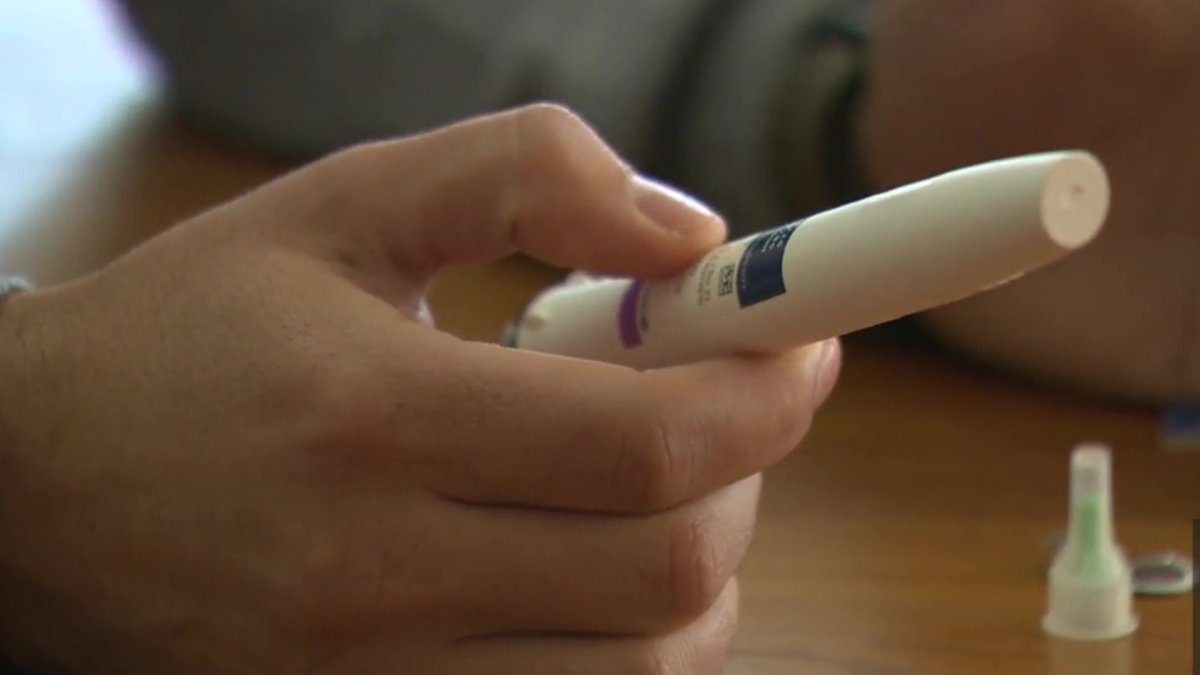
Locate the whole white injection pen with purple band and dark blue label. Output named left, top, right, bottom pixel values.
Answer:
left=505, top=151, right=1109, bottom=369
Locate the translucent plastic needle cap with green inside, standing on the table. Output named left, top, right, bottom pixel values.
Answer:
left=1042, top=443, right=1138, bottom=640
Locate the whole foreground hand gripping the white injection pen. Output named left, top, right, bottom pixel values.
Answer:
left=0, top=106, right=840, bottom=675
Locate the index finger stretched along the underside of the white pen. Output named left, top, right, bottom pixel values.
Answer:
left=394, top=340, right=840, bottom=513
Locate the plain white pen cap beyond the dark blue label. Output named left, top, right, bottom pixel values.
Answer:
left=775, top=151, right=1109, bottom=345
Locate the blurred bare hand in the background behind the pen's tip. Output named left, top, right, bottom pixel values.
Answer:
left=859, top=0, right=1200, bottom=401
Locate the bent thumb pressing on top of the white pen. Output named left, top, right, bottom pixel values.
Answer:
left=268, top=104, right=726, bottom=281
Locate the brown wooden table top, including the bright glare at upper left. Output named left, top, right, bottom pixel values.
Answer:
left=0, top=0, right=1200, bottom=675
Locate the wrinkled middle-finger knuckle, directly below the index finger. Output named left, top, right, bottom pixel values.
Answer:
left=665, top=511, right=727, bottom=617
